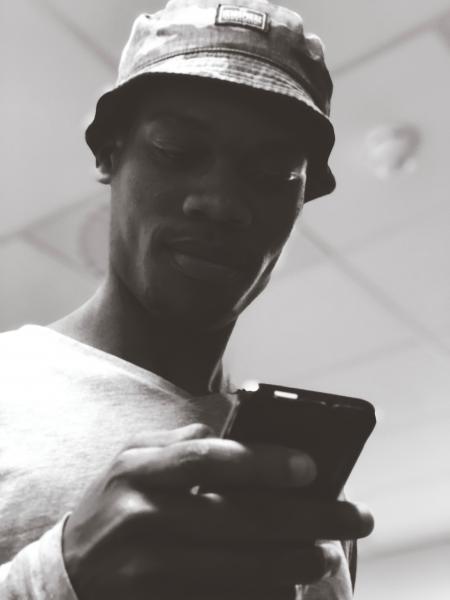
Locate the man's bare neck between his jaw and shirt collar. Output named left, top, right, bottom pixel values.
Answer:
left=49, top=277, right=233, bottom=395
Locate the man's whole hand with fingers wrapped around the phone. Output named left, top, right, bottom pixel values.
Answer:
left=63, top=425, right=373, bottom=600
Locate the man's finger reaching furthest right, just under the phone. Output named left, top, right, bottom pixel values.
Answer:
left=121, top=490, right=373, bottom=545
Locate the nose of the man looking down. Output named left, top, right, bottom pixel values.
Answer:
left=183, top=165, right=252, bottom=228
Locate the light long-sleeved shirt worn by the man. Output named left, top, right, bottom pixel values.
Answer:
left=0, top=325, right=351, bottom=600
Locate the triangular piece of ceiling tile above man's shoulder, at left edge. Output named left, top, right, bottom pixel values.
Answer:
left=0, top=237, right=96, bottom=331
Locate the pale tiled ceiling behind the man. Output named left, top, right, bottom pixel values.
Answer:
left=0, top=0, right=450, bottom=568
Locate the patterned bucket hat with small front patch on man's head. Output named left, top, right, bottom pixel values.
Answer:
left=85, top=0, right=336, bottom=201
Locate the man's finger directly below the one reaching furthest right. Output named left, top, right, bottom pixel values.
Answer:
left=105, top=538, right=341, bottom=591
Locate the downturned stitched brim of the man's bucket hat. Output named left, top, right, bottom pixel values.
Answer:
left=85, top=50, right=336, bottom=202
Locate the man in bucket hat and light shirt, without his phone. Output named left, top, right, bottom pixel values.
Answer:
left=0, top=0, right=373, bottom=600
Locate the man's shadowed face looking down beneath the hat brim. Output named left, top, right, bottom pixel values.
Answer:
left=106, top=78, right=307, bottom=330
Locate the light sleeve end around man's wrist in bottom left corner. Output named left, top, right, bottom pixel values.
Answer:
left=0, top=514, right=78, bottom=600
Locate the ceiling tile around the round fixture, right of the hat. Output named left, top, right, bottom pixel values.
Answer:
left=303, top=34, right=450, bottom=249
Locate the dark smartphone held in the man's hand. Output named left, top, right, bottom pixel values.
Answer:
left=223, top=383, right=376, bottom=500
